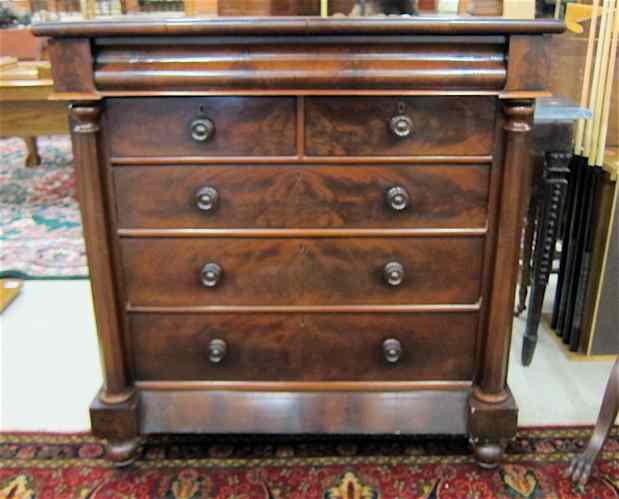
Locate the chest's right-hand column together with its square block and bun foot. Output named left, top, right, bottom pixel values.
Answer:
left=468, top=100, right=533, bottom=468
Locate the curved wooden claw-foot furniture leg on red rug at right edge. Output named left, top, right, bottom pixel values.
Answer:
left=567, top=358, right=619, bottom=485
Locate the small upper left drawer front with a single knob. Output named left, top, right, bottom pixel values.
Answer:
left=106, top=97, right=296, bottom=157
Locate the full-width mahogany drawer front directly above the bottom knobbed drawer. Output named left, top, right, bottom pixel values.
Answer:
left=122, top=237, right=484, bottom=306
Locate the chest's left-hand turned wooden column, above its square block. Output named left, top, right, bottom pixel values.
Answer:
left=70, top=104, right=133, bottom=404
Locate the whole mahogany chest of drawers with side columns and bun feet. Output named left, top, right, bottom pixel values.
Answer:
left=35, top=18, right=563, bottom=466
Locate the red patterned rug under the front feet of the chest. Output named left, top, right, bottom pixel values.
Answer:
left=0, top=428, right=619, bottom=499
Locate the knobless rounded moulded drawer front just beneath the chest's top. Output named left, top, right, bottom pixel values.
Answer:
left=94, top=37, right=506, bottom=91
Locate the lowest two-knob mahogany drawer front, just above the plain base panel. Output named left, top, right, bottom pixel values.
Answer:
left=131, top=312, right=478, bottom=381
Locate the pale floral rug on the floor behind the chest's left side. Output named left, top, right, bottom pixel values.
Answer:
left=0, top=136, right=88, bottom=279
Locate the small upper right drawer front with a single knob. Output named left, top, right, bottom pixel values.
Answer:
left=305, top=96, right=496, bottom=156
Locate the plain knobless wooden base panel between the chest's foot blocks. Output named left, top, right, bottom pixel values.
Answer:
left=141, top=389, right=470, bottom=435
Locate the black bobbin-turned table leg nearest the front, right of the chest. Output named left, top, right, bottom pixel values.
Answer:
left=522, top=152, right=571, bottom=366
